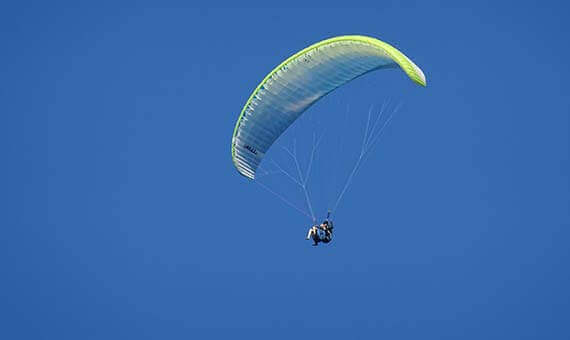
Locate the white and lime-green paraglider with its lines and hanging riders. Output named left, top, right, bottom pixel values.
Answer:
left=231, top=35, right=426, bottom=244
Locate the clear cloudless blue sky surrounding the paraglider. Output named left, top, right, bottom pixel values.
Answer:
left=0, top=1, right=570, bottom=339
